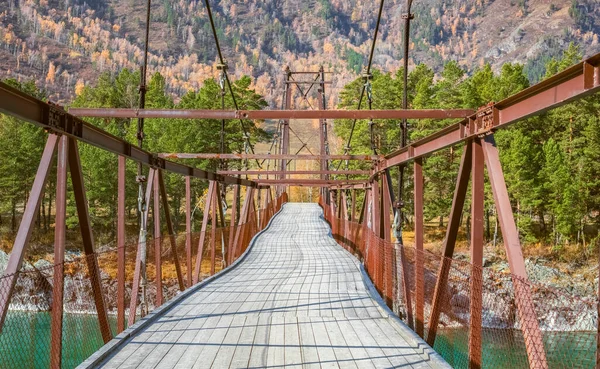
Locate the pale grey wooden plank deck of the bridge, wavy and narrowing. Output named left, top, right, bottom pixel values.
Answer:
left=88, top=203, right=448, bottom=369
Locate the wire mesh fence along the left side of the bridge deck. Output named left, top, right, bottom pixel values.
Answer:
left=0, top=194, right=285, bottom=369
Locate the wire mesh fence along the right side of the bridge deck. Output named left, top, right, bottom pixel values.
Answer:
left=321, top=198, right=598, bottom=368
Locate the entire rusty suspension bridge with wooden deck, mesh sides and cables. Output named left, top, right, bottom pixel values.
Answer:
left=0, top=0, right=600, bottom=369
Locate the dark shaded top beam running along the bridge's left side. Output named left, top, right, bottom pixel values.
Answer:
left=0, top=82, right=255, bottom=186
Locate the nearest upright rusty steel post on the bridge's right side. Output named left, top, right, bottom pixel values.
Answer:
left=469, top=139, right=485, bottom=369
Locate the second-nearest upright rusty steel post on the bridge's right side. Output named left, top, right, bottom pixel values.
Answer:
left=413, top=158, right=425, bottom=338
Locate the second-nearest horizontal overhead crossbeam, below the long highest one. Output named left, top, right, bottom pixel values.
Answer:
left=158, top=153, right=383, bottom=161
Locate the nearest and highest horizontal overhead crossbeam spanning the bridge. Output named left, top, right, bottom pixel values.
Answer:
left=69, top=108, right=474, bottom=120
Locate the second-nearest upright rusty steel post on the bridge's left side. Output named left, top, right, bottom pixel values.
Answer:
left=117, top=155, right=127, bottom=334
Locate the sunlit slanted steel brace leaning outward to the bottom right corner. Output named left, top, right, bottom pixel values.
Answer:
left=482, top=135, right=548, bottom=369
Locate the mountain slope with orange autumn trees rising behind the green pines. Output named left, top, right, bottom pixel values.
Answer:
left=0, top=0, right=600, bottom=108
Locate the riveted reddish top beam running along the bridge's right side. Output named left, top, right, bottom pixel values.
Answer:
left=377, top=54, right=600, bottom=171
